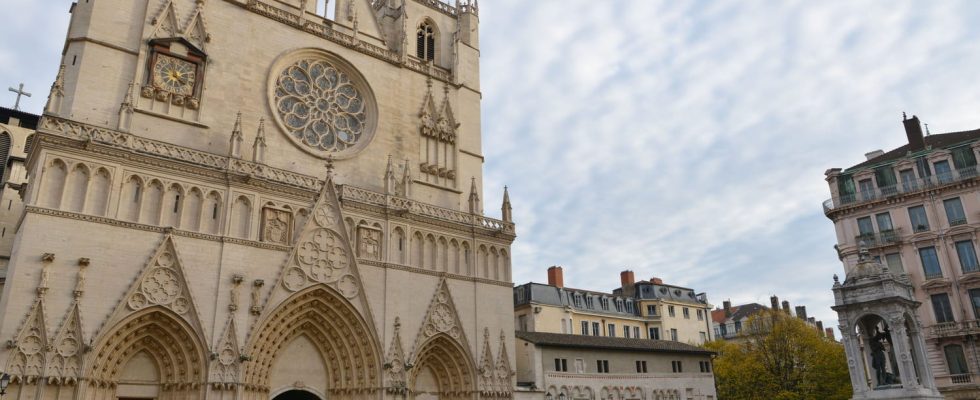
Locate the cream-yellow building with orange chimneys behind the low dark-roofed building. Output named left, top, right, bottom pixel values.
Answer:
left=514, top=266, right=712, bottom=345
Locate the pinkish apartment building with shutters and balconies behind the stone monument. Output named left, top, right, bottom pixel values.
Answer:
left=824, top=116, right=980, bottom=399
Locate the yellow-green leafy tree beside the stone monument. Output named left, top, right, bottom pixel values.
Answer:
left=706, top=311, right=852, bottom=400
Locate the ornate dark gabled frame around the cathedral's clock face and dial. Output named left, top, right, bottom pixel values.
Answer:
left=140, top=38, right=207, bottom=110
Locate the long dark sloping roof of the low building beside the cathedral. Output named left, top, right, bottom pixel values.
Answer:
left=515, top=331, right=715, bottom=355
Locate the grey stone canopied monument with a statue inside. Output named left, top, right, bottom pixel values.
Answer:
left=833, top=247, right=943, bottom=400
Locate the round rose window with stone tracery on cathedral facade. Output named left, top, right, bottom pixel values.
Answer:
left=272, top=58, right=370, bottom=153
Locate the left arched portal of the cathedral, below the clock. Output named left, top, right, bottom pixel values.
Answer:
left=85, top=306, right=207, bottom=399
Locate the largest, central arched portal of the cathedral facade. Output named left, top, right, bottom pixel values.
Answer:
left=244, top=285, right=382, bottom=399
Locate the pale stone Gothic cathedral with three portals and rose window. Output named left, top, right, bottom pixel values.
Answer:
left=0, top=0, right=515, bottom=400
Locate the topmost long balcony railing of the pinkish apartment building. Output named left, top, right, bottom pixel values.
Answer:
left=823, top=166, right=980, bottom=214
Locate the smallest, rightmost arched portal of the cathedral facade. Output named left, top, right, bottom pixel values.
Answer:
left=409, top=333, right=476, bottom=399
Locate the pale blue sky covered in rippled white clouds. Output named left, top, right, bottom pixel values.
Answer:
left=0, top=0, right=980, bottom=332
